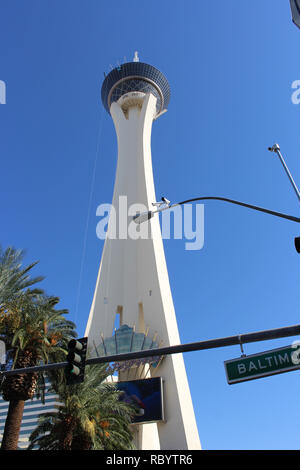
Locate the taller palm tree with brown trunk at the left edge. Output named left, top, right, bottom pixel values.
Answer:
left=0, top=289, right=76, bottom=450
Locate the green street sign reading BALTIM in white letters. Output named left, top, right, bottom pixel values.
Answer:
left=224, top=342, right=300, bottom=384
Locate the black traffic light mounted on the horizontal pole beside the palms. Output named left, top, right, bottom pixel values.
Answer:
left=65, top=338, right=87, bottom=385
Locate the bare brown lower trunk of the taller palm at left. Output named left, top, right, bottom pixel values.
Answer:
left=1, top=400, right=25, bottom=450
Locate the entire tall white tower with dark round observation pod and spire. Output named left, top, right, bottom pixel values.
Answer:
left=85, top=53, right=201, bottom=450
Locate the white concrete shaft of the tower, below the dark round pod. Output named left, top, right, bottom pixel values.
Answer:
left=85, top=62, right=200, bottom=450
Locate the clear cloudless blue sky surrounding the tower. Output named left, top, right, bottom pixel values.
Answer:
left=0, top=0, right=300, bottom=449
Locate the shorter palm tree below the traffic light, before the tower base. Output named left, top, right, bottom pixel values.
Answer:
left=28, top=364, right=135, bottom=450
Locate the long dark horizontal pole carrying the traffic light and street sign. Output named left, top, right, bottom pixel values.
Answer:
left=0, top=325, right=300, bottom=377
